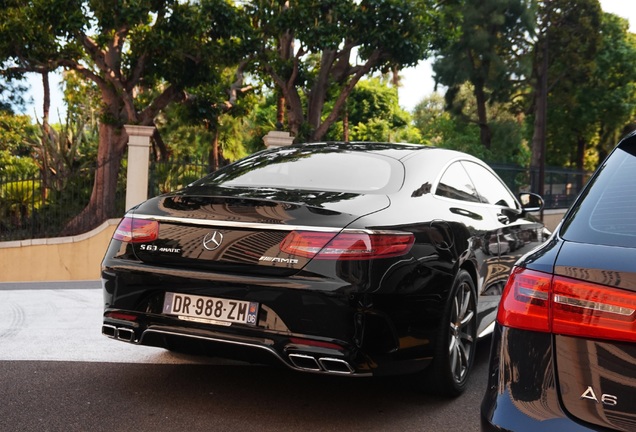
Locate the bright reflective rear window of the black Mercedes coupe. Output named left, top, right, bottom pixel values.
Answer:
left=195, top=148, right=404, bottom=193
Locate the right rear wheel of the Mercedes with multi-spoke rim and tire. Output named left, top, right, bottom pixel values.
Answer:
left=423, top=270, right=477, bottom=397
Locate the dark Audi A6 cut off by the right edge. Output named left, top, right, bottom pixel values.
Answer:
left=482, top=135, right=636, bottom=432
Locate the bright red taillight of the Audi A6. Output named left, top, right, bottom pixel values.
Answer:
left=497, top=268, right=636, bottom=342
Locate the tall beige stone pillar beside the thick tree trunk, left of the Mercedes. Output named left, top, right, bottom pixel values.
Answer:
left=124, top=125, right=155, bottom=210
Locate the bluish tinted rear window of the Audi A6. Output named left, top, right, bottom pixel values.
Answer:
left=561, top=145, right=636, bottom=248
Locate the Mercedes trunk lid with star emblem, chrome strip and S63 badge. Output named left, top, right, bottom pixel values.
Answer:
left=126, top=188, right=389, bottom=274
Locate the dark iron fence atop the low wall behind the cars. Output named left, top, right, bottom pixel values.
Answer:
left=0, top=162, right=590, bottom=241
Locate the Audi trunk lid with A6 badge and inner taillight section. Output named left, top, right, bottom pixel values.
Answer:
left=554, top=242, right=636, bottom=431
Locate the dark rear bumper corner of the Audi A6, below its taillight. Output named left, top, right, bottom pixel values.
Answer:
left=481, top=325, right=593, bottom=432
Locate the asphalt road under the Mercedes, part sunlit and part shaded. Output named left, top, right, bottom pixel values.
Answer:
left=0, top=281, right=490, bottom=432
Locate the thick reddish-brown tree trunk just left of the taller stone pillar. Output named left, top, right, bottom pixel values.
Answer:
left=62, top=123, right=128, bottom=236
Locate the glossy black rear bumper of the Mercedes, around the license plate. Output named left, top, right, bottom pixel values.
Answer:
left=102, top=267, right=442, bottom=376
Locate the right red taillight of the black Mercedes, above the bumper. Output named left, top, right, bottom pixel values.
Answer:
left=280, top=231, right=415, bottom=260
